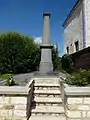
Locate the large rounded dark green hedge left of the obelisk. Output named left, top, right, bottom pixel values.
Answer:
left=0, top=32, right=40, bottom=74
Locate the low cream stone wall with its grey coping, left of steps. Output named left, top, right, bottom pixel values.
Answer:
left=0, top=81, right=34, bottom=120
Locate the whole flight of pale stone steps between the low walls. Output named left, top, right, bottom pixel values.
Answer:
left=30, top=78, right=66, bottom=120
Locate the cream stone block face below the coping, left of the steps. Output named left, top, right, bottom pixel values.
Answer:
left=0, top=95, right=27, bottom=120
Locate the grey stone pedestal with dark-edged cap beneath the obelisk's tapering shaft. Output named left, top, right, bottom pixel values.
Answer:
left=39, top=44, right=53, bottom=73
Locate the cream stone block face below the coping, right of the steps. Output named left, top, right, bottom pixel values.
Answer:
left=66, top=96, right=90, bottom=120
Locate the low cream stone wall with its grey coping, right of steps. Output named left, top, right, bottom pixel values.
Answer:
left=60, top=78, right=90, bottom=120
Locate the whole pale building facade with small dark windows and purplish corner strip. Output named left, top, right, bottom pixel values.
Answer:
left=63, top=0, right=90, bottom=54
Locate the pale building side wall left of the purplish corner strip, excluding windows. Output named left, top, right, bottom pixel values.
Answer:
left=64, top=0, right=83, bottom=54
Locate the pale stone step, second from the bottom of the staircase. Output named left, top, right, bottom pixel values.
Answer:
left=31, top=105, right=65, bottom=115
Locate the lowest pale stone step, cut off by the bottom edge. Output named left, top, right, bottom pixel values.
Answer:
left=29, top=115, right=66, bottom=120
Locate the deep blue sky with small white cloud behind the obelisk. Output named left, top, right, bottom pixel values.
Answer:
left=0, top=0, right=77, bottom=56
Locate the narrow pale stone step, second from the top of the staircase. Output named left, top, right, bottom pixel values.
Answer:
left=34, top=90, right=61, bottom=95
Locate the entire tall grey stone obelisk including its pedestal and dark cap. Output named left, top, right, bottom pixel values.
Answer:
left=39, top=13, right=53, bottom=75
